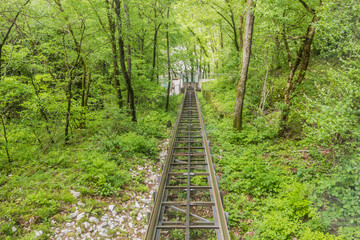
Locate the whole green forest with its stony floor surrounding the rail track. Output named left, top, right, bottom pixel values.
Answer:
left=0, top=0, right=360, bottom=240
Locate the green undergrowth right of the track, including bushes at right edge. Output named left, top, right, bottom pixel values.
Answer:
left=199, top=66, right=360, bottom=240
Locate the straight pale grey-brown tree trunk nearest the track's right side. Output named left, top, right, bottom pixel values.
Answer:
left=233, top=0, right=255, bottom=131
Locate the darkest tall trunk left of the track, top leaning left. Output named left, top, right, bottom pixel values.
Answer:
left=115, top=0, right=136, bottom=122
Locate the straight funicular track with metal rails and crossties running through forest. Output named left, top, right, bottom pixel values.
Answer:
left=145, top=86, right=230, bottom=240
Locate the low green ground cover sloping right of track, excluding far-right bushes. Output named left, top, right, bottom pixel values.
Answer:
left=199, top=80, right=360, bottom=240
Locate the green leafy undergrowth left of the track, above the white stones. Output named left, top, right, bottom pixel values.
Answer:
left=0, top=91, right=180, bottom=239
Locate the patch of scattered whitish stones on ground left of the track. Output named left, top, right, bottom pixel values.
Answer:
left=45, top=141, right=168, bottom=240
